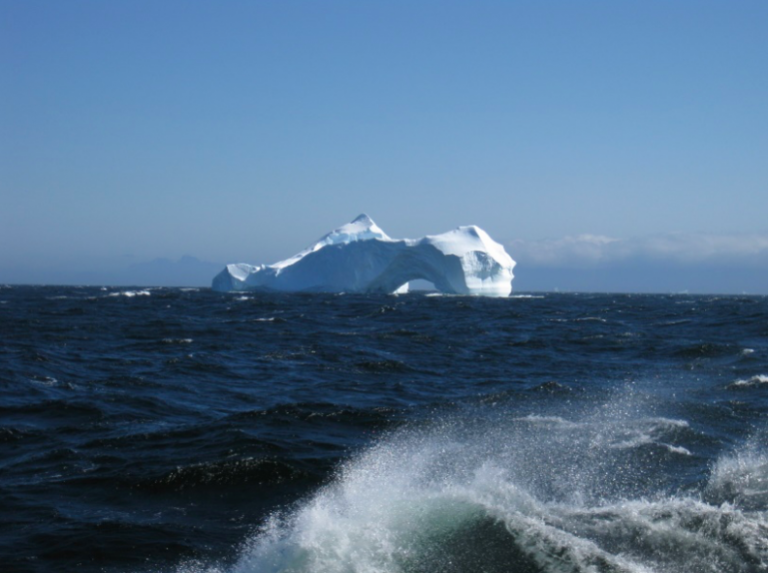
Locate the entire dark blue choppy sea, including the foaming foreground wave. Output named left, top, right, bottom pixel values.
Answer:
left=0, top=286, right=768, bottom=573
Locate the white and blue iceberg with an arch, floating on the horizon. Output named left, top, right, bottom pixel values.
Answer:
left=212, top=214, right=515, bottom=297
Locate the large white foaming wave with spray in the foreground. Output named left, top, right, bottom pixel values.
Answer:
left=179, top=398, right=768, bottom=573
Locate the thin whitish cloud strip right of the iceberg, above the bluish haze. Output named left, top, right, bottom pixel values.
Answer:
left=506, top=234, right=768, bottom=268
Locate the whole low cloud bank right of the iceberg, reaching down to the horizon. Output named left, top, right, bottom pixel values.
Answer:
left=505, top=234, right=768, bottom=294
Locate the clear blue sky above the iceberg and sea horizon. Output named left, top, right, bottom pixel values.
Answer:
left=0, top=0, right=768, bottom=292
